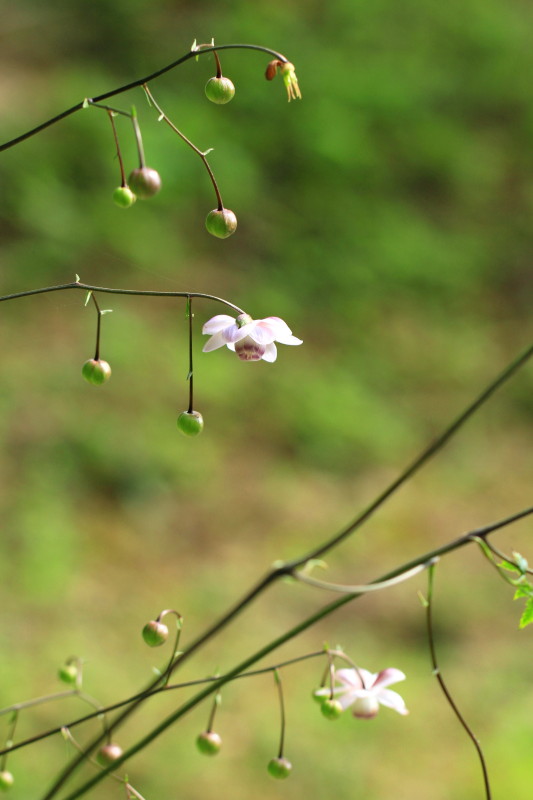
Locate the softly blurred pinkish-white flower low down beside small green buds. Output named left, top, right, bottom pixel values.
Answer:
left=315, top=667, right=409, bottom=719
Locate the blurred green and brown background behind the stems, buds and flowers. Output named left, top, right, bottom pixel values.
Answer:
left=0, top=0, right=533, bottom=800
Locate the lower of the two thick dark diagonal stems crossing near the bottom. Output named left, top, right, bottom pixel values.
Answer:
left=43, top=507, right=533, bottom=800
